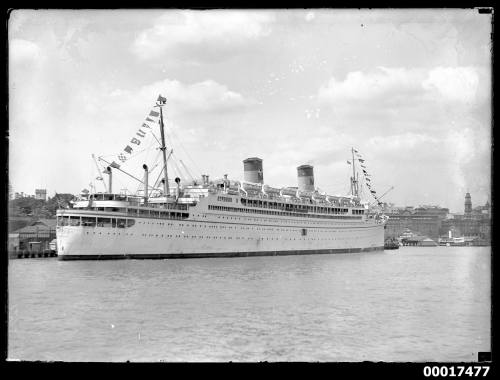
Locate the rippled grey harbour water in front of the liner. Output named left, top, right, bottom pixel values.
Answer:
left=8, top=247, right=491, bottom=362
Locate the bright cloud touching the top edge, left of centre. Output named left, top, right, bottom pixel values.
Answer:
left=132, top=11, right=274, bottom=59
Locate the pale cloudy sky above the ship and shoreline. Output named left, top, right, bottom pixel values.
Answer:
left=8, top=9, right=492, bottom=212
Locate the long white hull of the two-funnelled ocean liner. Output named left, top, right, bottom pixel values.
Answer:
left=57, top=211, right=384, bottom=259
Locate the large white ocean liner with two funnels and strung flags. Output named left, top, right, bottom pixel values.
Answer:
left=56, top=95, right=387, bottom=260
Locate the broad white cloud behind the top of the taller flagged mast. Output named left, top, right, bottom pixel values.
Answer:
left=73, top=78, right=254, bottom=151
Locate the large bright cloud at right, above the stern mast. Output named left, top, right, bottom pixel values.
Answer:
left=315, top=67, right=490, bottom=137
